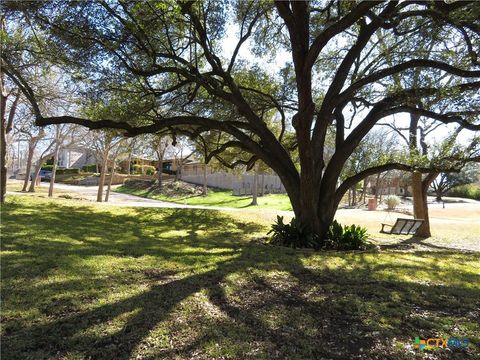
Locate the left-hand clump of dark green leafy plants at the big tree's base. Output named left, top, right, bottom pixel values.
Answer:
left=267, top=215, right=318, bottom=248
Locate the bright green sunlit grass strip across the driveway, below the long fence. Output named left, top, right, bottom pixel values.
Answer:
left=114, top=183, right=292, bottom=210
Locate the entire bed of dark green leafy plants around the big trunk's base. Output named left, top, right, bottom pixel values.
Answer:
left=267, top=216, right=368, bottom=250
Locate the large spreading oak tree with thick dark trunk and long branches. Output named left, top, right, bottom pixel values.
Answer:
left=2, top=0, right=480, bottom=237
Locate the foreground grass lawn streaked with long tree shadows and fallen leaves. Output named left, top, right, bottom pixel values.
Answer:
left=1, top=196, right=480, bottom=360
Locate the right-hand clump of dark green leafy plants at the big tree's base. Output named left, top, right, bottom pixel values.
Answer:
left=325, top=220, right=368, bottom=250
